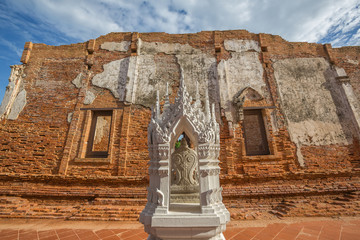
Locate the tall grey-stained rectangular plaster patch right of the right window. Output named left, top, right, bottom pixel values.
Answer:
left=274, top=58, right=349, bottom=165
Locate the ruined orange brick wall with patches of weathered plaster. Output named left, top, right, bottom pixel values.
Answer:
left=0, top=30, right=360, bottom=220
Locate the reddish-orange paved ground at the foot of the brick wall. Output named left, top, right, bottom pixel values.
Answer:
left=0, top=218, right=360, bottom=240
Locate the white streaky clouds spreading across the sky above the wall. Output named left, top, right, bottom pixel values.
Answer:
left=2, top=0, right=360, bottom=44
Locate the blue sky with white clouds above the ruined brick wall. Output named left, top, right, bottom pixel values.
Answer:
left=0, top=0, right=360, bottom=100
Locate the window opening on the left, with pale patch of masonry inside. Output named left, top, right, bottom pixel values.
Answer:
left=86, top=111, right=112, bottom=158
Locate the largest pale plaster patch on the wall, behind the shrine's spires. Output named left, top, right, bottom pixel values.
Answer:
left=92, top=40, right=217, bottom=107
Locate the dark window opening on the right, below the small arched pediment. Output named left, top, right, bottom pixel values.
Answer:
left=244, top=109, right=270, bottom=156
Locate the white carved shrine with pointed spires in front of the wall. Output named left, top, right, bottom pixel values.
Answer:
left=140, top=73, right=230, bottom=240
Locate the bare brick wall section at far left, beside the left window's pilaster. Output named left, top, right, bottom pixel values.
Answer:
left=0, top=44, right=85, bottom=174
